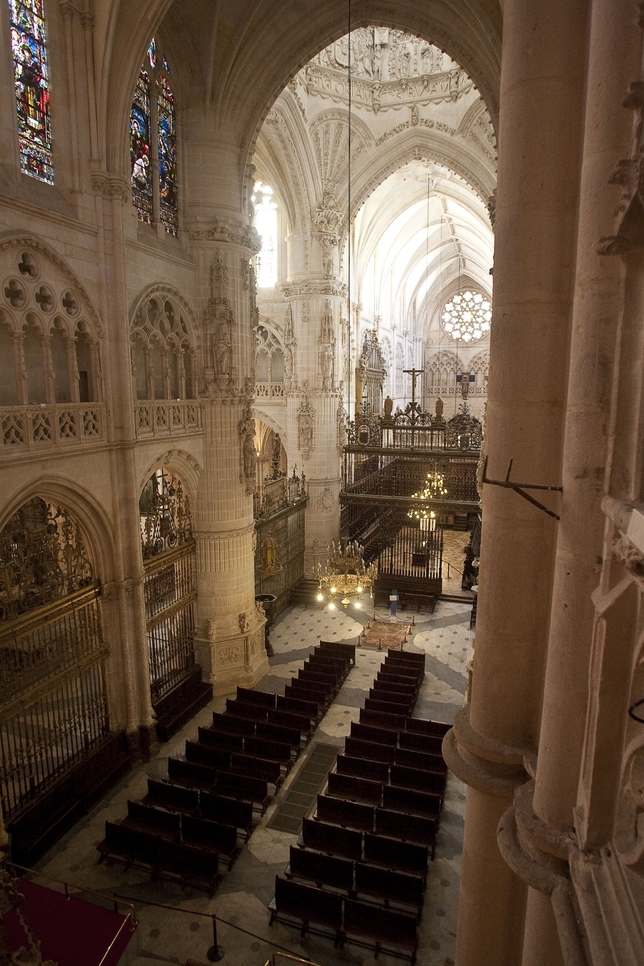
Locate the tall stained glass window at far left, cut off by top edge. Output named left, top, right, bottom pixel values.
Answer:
left=9, top=0, right=54, bottom=184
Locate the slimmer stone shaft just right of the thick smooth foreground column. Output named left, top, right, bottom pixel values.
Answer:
left=509, top=7, right=640, bottom=966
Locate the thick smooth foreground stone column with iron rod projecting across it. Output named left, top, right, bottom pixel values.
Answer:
left=445, top=0, right=586, bottom=966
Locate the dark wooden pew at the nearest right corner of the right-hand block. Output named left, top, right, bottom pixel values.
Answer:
left=340, top=899, right=418, bottom=966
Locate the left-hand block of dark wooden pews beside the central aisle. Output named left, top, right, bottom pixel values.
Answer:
left=97, top=644, right=355, bottom=895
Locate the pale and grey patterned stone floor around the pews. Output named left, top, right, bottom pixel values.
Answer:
left=32, top=601, right=473, bottom=966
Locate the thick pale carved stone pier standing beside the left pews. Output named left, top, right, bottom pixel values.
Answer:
left=190, top=233, right=268, bottom=694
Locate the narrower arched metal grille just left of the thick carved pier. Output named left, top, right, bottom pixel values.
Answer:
left=139, top=469, right=197, bottom=705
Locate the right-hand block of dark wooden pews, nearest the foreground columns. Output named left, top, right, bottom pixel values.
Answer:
left=270, top=652, right=449, bottom=964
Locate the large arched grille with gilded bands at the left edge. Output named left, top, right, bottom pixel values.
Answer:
left=0, top=497, right=109, bottom=820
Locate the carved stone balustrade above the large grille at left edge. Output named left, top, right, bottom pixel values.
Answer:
left=0, top=403, right=106, bottom=459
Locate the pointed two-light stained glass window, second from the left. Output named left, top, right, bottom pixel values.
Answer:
left=130, top=37, right=178, bottom=235
